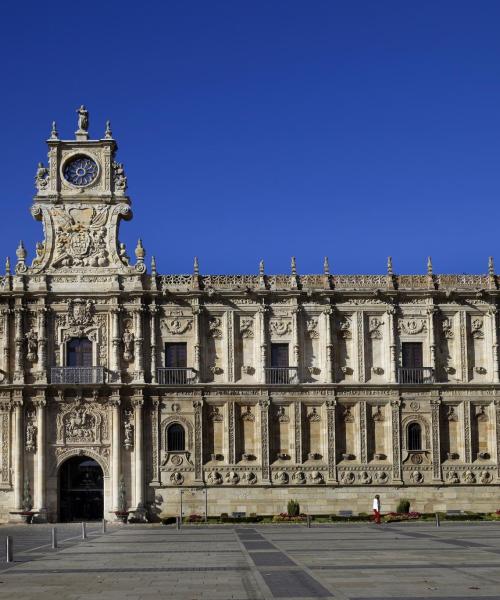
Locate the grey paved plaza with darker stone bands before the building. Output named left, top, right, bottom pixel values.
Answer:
left=0, top=523, right=500, bottom=600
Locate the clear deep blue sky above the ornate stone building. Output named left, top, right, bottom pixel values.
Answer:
left=0, top=0, right=500, bottom=273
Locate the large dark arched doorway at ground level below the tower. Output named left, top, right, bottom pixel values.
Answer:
left=59, top=456, right=104, bottom=521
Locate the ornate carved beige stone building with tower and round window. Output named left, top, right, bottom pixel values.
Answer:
left=0, top=107, right=500, bottom=520
